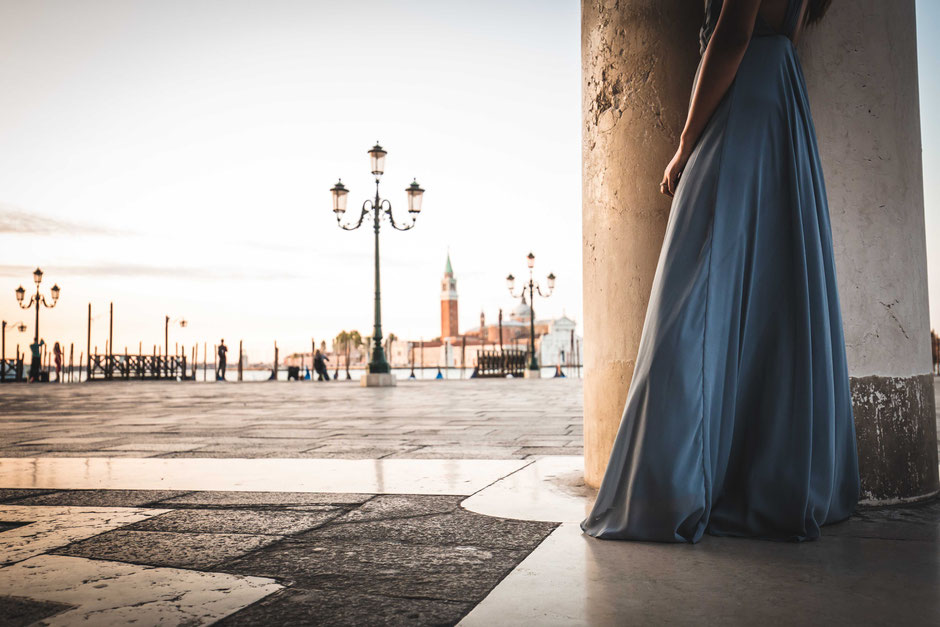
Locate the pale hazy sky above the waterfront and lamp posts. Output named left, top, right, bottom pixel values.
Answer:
left=0, top=0, right=940, bottom=360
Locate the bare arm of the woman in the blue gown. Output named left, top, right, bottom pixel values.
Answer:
left=660, top=0, right=761, bottom=196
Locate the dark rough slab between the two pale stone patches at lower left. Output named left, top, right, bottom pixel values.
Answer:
left=55, top=529, right=281, bottom=570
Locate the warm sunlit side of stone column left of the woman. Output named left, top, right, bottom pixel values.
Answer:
left=581, top=0, right=703, bottom=486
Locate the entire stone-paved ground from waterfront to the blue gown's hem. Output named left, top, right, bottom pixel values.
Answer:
left=0, top=380, right=940, bottom=625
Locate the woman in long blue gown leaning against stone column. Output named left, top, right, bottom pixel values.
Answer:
left=581, top=0, right=859, bottom=542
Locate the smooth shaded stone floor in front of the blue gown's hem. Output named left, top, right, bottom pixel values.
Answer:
left=460, top=523, right=940, bottom=626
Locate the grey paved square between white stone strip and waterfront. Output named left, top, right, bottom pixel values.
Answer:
left=0, top=379, right=582, bottom=459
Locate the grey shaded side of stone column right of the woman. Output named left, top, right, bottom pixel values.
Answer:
left=800, top=0, right=940, bottom=503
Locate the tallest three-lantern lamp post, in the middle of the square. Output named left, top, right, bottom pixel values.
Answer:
left=330, top=142, right=424, bottom=387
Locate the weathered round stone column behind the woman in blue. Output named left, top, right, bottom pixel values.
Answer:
left=582, top=0, right=938, bottom=503
